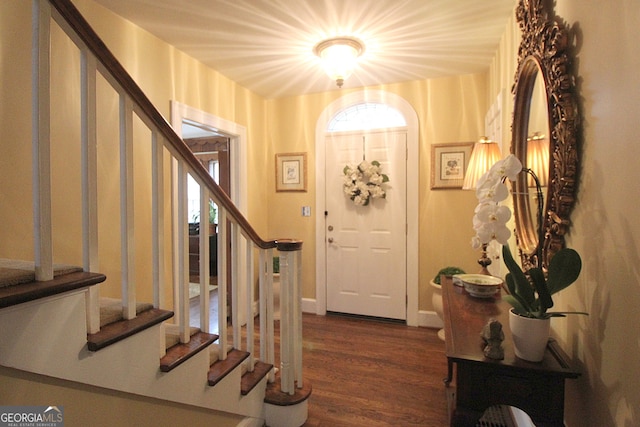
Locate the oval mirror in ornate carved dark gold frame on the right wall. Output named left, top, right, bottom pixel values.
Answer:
left=511, top=0, right=579, bottom=269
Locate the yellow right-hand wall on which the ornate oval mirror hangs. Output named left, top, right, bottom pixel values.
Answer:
left=489, top=0, right=640, bottom=426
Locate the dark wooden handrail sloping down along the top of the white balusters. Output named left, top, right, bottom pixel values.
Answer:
left=49, top=0, right=277, bottom=249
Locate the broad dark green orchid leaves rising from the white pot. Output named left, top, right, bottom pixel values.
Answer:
left=502, top=245, right=587, bottom=319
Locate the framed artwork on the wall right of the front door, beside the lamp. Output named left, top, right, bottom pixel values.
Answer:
left=431, top=142, right=473, bottom=190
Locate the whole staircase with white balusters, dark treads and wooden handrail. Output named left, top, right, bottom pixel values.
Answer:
left=0, top=0, right=311, bottom=427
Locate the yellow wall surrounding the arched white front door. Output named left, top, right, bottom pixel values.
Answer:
left=268, top=74, right=488, bottom=310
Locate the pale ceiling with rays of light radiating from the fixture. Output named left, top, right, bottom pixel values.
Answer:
left=96, top=0, right=516, bottom=98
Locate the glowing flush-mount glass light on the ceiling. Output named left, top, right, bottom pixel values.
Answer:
left=313, top=37, right=364, bottom=87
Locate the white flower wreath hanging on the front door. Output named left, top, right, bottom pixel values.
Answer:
left=342, top=160, right=389, bottom=206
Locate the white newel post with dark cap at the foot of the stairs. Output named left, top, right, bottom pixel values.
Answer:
left=276, top=240, right=302, bottom=395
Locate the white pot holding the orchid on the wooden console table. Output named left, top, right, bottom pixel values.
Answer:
left=509, top=309, right=551, bottom=362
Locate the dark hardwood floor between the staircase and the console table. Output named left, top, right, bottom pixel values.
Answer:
left=303, top=314, right=448, bottom=427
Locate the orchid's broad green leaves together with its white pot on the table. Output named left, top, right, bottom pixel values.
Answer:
left=502, top=245, right=587, bottom=362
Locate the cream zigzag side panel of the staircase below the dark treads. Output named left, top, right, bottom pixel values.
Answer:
left=0, top=289, right=267, bottom=419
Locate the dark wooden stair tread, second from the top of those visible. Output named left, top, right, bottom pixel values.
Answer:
left=87, top=308, right=173, bottom=351
